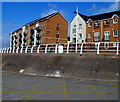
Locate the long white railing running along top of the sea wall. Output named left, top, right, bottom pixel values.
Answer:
left=0, top=42, right=120, bottom=55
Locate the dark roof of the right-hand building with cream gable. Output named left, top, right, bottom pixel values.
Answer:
left=74, top=10, right=120, bottom=22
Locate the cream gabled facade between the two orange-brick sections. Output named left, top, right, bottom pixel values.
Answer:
left=70, top=12, right=86, bottom=43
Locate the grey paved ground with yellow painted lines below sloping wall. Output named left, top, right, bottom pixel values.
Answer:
left=2, top=72, right=119, bottom=102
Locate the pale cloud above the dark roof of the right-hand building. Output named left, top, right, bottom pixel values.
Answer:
left=87, top=2, right=118, bottom=14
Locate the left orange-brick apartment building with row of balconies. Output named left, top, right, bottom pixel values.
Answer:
left=10, top=12, right=68, bottom=47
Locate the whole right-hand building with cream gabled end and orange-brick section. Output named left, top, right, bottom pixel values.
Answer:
left=70, top=11, right=120, bottom=45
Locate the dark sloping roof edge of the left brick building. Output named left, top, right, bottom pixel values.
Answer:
left=12, top=12, right=59, bottom=34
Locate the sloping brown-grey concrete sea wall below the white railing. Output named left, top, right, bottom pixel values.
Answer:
left=2, top=54, right=120, bottom=80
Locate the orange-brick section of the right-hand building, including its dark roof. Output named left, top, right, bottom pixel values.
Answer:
left=86, top=11, right=120, bottom=42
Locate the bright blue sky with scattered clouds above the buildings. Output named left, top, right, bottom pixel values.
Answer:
left=0, top=2, right=118, bottom=48
